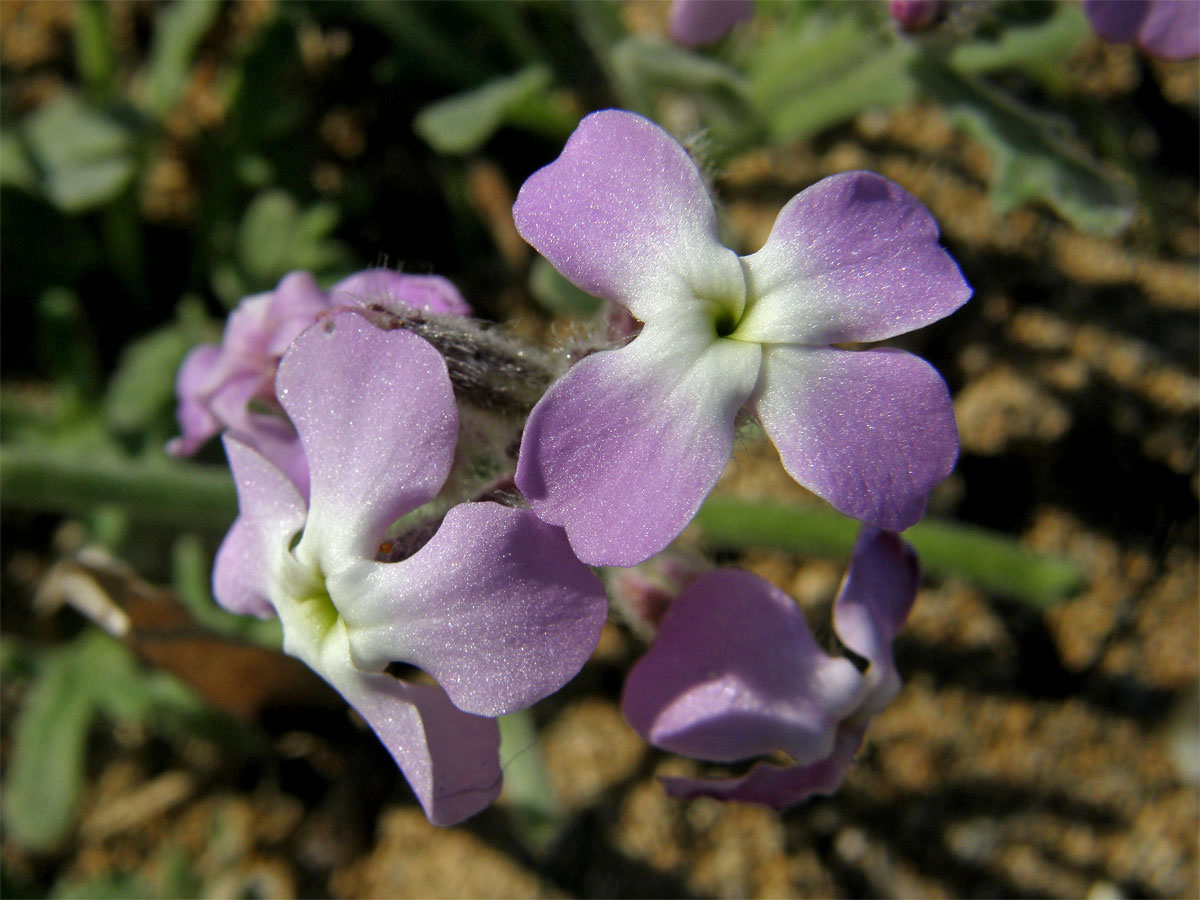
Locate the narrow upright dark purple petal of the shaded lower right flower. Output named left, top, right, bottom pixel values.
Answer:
left=833, top=526, right=920, bottom=719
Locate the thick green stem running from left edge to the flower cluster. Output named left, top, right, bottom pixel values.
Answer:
left=0, top=446, right=238, bottom=529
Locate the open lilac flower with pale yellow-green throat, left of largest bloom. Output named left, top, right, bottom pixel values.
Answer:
left=214, top=311, right=607, bottom=824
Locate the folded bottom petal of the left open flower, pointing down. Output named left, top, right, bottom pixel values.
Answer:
left=320, top=665, right=503, bottom=826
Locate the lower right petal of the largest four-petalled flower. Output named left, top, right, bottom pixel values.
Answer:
left=752, top=346, right=959, bottom=532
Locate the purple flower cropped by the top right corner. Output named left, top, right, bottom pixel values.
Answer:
left=1084, top=0, right=1200, bottom=60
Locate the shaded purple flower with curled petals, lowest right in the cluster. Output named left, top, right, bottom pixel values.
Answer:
left=622, top=527, right=918, bottom=810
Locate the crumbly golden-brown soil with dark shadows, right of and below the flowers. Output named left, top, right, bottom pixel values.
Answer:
left=4, top=8, right=1200, bottom=899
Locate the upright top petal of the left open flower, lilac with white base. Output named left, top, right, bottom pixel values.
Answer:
left=276, top=312, right=458, bottom=566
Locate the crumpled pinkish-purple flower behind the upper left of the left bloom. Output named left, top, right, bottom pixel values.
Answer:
left=167, top=269, right=470, bottom=493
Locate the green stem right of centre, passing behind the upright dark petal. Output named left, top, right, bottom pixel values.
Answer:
left=694, top=494, right=1082, bottom=607
